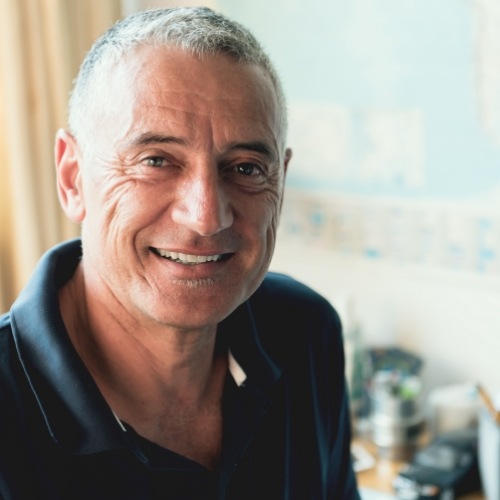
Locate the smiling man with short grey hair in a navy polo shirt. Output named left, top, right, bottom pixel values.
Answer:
left=0, top=8, right=358, bottom=500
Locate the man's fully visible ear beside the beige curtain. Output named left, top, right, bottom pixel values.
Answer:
left=55, top=129, right=85, bottom=223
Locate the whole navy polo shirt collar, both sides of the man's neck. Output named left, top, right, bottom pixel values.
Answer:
left=11, top=239, right=280, bottom=454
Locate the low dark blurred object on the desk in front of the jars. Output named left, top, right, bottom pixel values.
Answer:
left=393, top=430, right=480, bottom=500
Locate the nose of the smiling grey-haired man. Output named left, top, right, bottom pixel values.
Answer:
left=172, top=166, right=233, bottom=236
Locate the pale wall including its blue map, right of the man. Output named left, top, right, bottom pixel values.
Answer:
left=130, top=0, right=500, bottom=396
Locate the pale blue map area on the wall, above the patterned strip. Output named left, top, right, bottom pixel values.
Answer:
left=217, top=0, right=500, bottom=204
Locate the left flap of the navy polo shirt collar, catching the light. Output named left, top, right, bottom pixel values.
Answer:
left=11, top=240, right=128, bottom=454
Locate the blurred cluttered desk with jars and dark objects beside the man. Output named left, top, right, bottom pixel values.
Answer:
left=352, top=349, right=500, bottom=500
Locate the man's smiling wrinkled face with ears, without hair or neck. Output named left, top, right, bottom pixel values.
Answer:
left=56, top=46, right=290, bottom=338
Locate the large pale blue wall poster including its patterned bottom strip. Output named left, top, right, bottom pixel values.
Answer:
left=216, top=0, right=500, bottom=275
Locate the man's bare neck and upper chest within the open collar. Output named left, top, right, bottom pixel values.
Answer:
left=59, top=265, right=227, bottom=469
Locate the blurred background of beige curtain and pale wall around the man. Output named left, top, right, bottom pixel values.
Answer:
left=0, top=0, right=500, bottom=438
